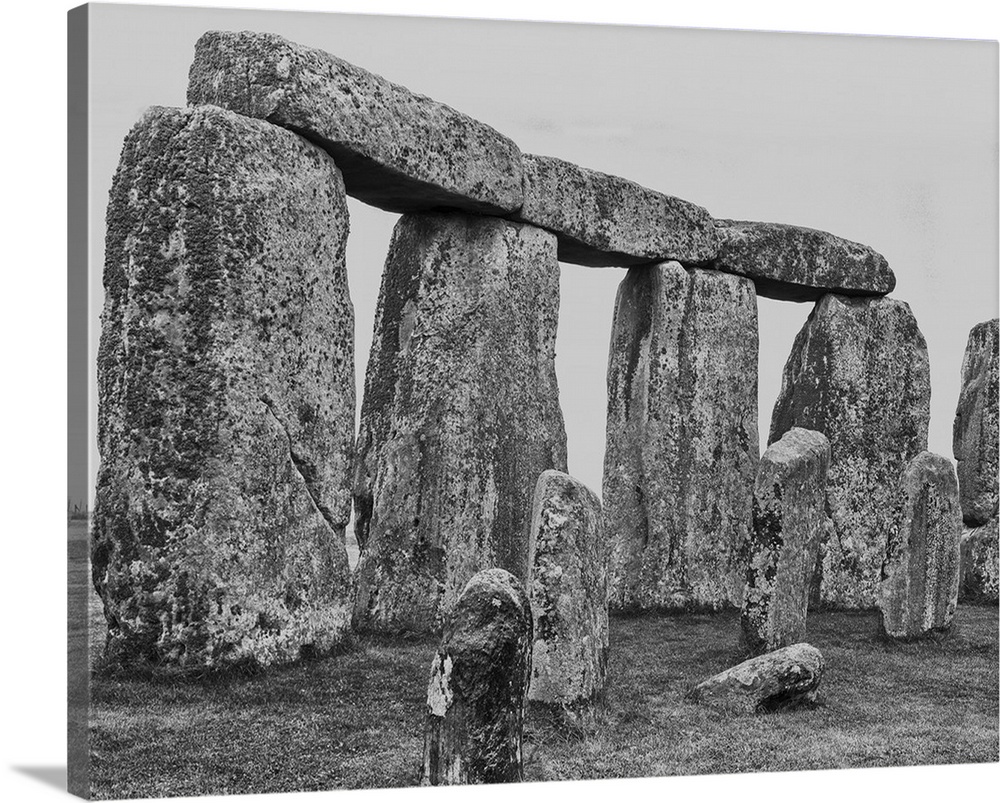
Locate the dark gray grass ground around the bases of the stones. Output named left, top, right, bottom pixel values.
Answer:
left=80, top=532, right=1000, bottom=799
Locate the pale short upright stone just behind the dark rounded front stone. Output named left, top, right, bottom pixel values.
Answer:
left=528, top=471, right=608, bottom=711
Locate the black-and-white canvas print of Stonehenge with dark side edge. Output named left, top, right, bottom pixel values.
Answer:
left=68, top=4, right=998, bottom=799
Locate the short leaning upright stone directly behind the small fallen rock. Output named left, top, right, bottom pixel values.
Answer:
left=740, top=427, right=830, bottom=653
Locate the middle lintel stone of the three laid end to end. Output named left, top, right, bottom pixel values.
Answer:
left=516, top=154, right=718, bottom=267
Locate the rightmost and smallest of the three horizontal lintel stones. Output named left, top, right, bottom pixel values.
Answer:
left=713, top=220, right=896, bottom=301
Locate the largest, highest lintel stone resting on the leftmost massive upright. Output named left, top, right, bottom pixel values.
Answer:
left=188, top=31, right=522, bottom=214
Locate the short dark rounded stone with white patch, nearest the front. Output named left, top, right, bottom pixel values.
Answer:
left=421, top=569, right=531, bottom=786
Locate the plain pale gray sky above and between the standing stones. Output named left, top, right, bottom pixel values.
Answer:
left=86, top=4, right=998, bottom=506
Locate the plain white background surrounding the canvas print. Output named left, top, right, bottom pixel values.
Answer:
left=0, top=0, right=1000, bottom=801
